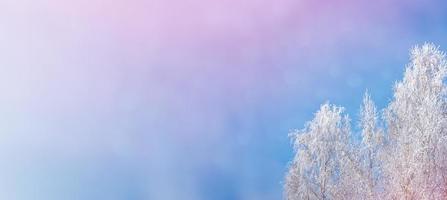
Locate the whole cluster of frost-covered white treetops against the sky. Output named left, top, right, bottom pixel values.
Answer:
left=284, top=44, right=447, bottom=200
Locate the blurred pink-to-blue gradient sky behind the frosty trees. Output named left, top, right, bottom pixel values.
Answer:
left=0, top=0, right=447, bottom=200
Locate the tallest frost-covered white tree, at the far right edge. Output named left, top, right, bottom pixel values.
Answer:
left=385, top=44, right=447, bottom=199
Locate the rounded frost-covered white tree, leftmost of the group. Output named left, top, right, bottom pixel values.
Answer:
left=285, top=103, right=350, bottom=200
